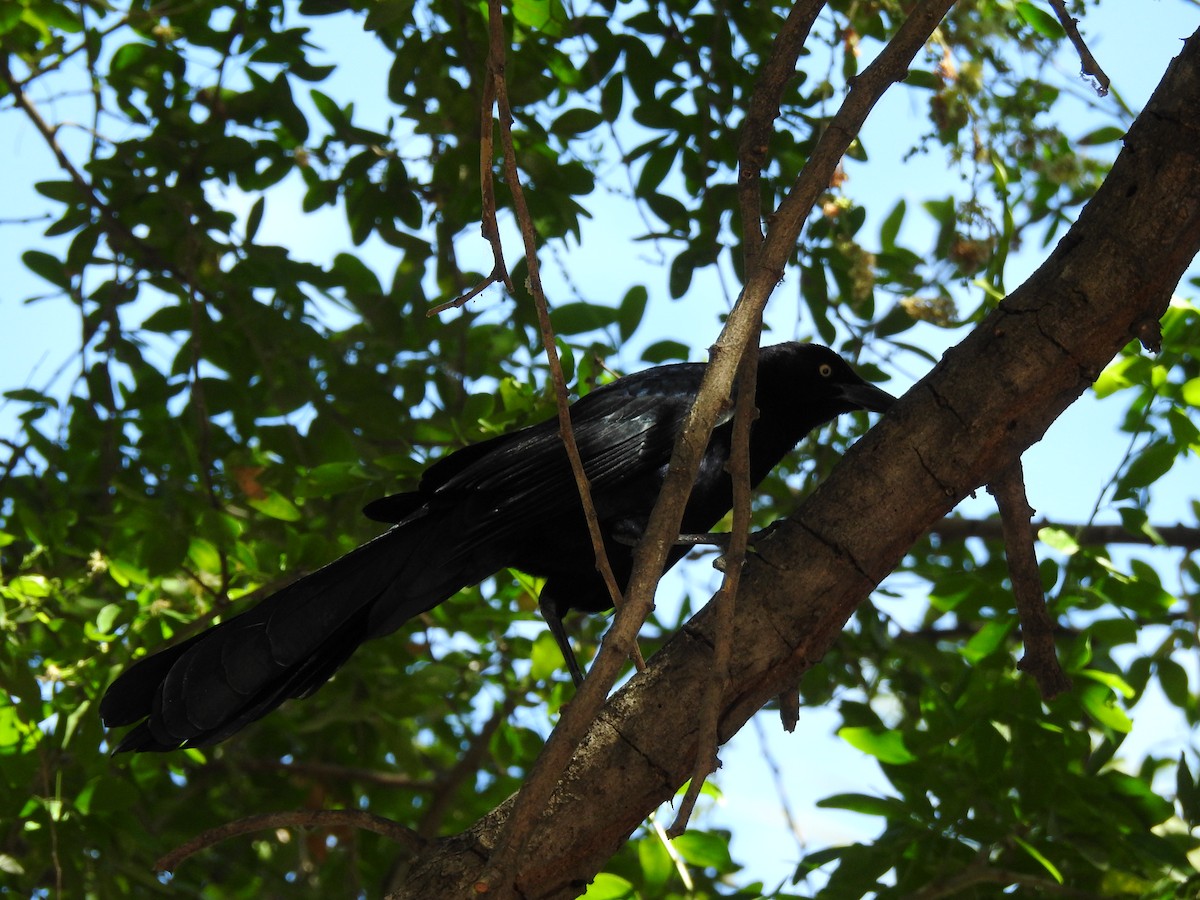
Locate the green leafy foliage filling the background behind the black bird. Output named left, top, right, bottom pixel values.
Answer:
left=0, top=0, right=1200, bottom=898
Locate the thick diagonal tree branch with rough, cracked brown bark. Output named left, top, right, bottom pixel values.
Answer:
left=392, top=28, right=1200, bottom=898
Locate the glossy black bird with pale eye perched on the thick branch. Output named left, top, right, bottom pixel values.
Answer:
left=100, top=343, right=893, bottom=752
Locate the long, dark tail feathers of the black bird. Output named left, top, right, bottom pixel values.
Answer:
left=100, top=513, right=482, bottom=752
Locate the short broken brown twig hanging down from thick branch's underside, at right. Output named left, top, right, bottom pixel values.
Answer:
left=988, top=460, right=1070, bottom=700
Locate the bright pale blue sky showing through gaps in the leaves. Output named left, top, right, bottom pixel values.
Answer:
left=0, top=0, right=1200, bottom=886
